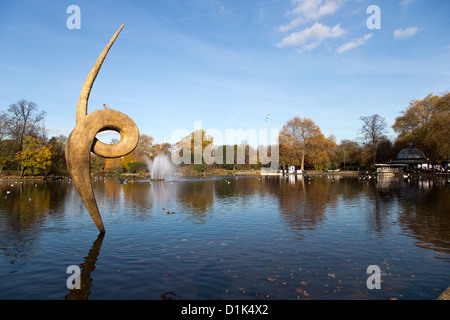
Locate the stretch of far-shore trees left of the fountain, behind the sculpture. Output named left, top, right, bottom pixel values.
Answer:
left=0, top=99, right=166, bottom=176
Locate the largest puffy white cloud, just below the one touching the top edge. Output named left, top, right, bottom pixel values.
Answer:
left=277, top=22, right=345, bottom=51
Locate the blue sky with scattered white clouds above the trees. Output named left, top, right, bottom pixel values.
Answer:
left=0, top=0, right=450, bottom=146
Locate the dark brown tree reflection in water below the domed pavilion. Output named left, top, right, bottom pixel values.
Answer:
left=368, top=177, right=450, bottom=253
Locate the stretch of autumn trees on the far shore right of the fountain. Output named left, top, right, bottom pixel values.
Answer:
left=174, top=92, right=450, bottom=171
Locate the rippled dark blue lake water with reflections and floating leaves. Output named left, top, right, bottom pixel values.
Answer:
left=0, top=176, right=450, bottom=300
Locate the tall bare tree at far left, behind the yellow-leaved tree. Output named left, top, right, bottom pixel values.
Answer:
left=7, top=99, right=45, bottom=151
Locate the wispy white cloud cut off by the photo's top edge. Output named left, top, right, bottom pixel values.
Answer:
left=278, top=0, right=346, bottom=32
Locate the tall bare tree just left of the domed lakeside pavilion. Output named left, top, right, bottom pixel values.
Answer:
left=359, top=114, right=387, bottom=165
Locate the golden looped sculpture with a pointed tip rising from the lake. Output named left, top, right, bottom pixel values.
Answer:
left=66, top=24, right=139, bottom=233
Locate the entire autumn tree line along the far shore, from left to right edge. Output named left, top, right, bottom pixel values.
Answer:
left=0, top=92, right=450, bottom=175
